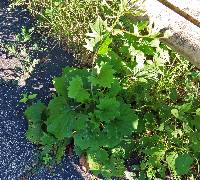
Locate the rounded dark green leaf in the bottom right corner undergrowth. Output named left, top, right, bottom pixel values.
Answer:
left=175, top=154, right=193, bottom=176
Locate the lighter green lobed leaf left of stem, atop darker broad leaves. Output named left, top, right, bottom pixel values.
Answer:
left=67, top=76, right=90, bottom=103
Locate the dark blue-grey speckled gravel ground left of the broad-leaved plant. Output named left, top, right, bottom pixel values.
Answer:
left=0, top=0, right=89, bottom=180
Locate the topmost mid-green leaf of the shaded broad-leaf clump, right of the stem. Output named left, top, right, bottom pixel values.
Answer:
left=89, top=63, right=114, bottom=88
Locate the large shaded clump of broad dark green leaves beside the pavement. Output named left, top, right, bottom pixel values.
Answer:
left=25, top=63, right=138, bottom=176
